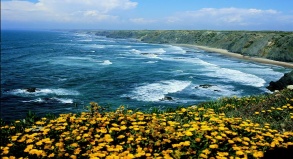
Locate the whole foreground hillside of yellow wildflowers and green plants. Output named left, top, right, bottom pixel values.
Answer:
left=0, top=90, right=293, bottom=159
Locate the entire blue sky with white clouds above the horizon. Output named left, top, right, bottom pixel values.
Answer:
left=1, top=0, right=293, bottom=31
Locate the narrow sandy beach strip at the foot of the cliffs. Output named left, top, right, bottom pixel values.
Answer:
left=175, top=44, right=293, bottom=68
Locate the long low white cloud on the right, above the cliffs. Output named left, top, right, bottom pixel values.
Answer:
left=167, top=8, right=292, bottom=26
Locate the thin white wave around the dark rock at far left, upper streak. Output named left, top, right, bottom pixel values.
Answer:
left=7, top=88, right=79, bottom=96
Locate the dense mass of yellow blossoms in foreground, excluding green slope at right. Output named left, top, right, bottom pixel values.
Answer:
left=0, top=103, right=293, bottom=159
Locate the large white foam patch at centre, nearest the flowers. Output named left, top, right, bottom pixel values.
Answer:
left=124, top=80, right=191, bottom=101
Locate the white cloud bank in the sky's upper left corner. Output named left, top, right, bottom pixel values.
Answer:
left=1, top=0, right=137, bottom=22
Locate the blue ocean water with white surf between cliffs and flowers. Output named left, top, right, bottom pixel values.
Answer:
left=1, top=31, right=289, bottom=120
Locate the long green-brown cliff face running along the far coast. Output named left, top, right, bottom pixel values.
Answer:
left=95, top=30, right=293, bottom=62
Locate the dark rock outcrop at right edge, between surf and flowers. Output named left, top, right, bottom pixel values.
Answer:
left=267, top=71, right=293, bottom=91
